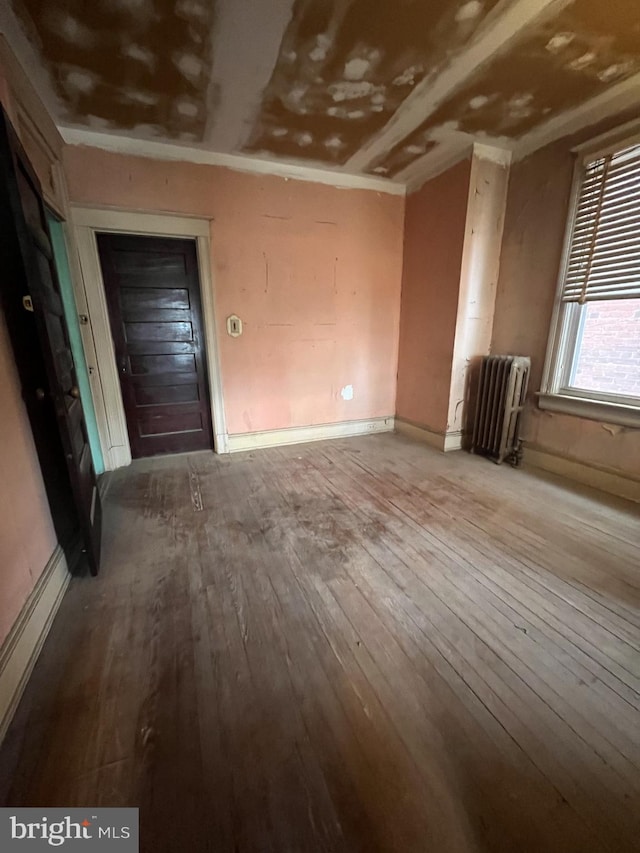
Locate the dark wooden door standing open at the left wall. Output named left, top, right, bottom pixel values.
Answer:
left=0, top=106, right=102, bottom=574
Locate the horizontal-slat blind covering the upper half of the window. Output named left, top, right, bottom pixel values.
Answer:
left=562, top=145, right=640, bottom=303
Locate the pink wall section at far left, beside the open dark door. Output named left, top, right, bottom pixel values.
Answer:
left=0, top=317, right=56, bottom=643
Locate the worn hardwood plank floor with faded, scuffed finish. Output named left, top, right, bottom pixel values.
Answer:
left=0, top=435, right=640, bottom=853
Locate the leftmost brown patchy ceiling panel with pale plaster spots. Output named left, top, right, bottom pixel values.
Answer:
left=12, top=0, right=215, bottom=142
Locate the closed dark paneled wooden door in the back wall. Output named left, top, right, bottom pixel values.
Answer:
left=98, top=234, right=213, bottom=458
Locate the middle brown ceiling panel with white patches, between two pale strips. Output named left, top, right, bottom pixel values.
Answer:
left=244, top=0, right=498, bottom=164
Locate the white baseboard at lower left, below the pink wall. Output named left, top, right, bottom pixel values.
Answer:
left=0, top=545, right=71, bottom=743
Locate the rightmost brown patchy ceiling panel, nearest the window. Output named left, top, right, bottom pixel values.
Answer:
left=380, top=0, right=640, bottom=175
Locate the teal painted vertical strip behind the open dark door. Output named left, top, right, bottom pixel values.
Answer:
left=47, top=213, right=104, bottom=474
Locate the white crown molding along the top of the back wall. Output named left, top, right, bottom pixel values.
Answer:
left=58, top=127, right=405, bottom=196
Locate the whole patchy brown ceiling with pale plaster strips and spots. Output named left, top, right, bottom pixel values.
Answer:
left=3, top=0, right=640, bottom=187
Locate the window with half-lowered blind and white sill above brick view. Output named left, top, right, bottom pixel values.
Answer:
left=539, top=135, right=640, bottom=425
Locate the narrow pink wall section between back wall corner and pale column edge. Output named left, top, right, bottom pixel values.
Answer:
left=396, top=160, right=471, bottom=433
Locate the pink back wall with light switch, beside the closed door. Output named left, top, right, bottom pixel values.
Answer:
left=64, top=146, right=404, bottom=434
